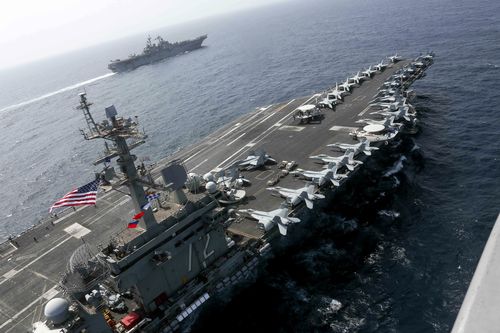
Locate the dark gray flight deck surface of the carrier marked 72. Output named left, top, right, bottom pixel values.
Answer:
left=0, top=61, right=408, bottom=333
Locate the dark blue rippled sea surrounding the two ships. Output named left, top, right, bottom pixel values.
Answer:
left=0, top=0, right=500, bottom=332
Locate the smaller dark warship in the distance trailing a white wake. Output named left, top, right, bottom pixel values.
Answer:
left=108, top=35, right=207, bottom=72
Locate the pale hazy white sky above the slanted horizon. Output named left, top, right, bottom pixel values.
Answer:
left=0, top=0, right=286, bottom=68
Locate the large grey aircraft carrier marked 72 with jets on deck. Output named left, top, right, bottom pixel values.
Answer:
left=0, top=54, right=433, bottom=332
